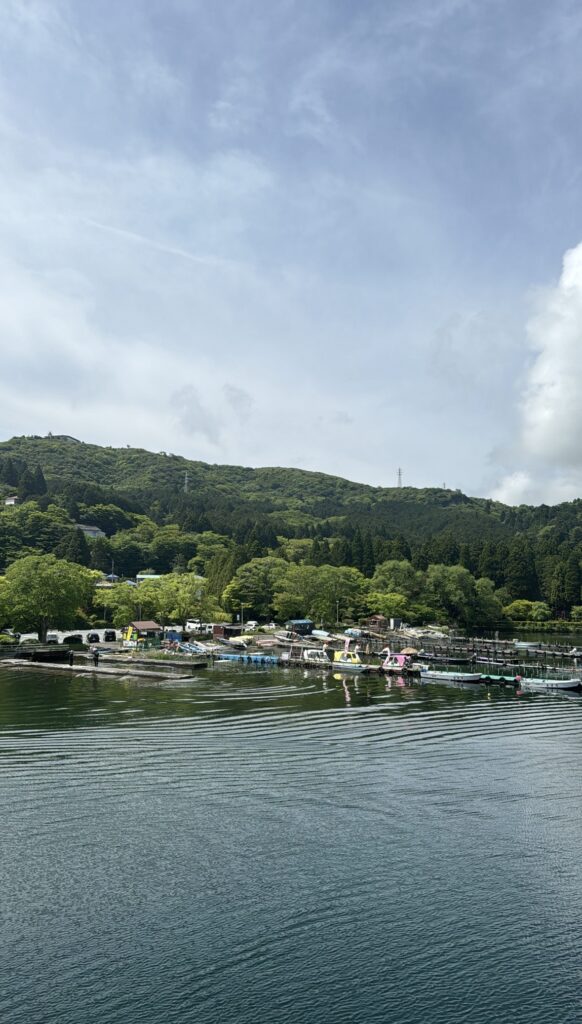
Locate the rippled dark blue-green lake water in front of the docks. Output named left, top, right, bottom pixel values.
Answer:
left=0, top=666, right=582, bottom=1024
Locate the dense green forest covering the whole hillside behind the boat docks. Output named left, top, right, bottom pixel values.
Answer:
left=0, top=435, right=582, bottom=626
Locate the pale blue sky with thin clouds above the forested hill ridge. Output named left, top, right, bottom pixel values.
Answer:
left=0, top=0, right=582, bottom=504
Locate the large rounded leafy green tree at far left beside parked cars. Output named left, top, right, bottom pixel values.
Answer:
left=4, top=555, right=97, bottom=642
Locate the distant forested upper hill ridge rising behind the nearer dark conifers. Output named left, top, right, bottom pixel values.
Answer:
left=0, top=436, right=545, bottom=541
